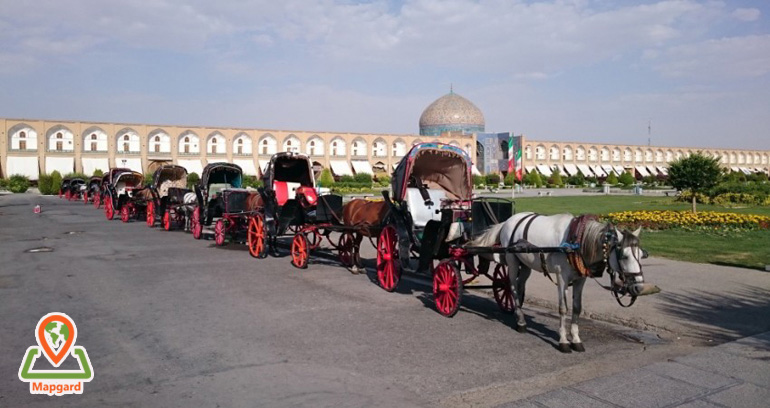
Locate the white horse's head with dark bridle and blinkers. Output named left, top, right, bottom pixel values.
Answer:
left=605, top=227, right=660, bottom=297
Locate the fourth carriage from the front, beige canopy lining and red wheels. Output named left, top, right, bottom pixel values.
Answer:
left=146, top=164, right=195, bottom=231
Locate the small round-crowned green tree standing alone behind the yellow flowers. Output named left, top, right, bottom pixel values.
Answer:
left=668, top=152, right=722, bottom=214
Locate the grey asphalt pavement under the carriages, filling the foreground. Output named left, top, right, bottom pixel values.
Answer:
left=0, top=194, right=770, bottom=407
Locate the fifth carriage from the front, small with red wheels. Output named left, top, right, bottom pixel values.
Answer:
left=104, top=169, right=146, bottom=222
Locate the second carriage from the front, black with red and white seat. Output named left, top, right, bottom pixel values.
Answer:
left=247, top=152, right=318, bottom=260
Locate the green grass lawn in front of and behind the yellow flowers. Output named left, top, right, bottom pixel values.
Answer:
left=516, top=196, right=770, bottom=270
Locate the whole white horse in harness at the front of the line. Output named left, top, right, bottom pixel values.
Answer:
left=469, top=213, right=660, bottom=353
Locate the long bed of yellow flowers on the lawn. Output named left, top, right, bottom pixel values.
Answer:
left=604, top=211, right=770, bottom=230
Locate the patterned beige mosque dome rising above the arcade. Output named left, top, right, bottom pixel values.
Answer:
left=420, top=90, right=484, bottom=136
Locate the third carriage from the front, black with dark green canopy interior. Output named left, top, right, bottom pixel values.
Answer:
left=190, top=162, right=248, bottom=241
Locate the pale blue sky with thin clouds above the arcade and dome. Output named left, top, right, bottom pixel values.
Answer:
left=0, top=0, right=770, bottom=150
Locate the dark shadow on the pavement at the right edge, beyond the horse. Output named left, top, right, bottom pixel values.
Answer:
left=658, top=284, right=770, bottom=341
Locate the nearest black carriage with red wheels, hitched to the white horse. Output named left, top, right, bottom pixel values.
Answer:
left=377, top=143, right=514, bottom=316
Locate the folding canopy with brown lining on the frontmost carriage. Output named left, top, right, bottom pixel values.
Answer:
left=391, top=143, right=473, bottom=201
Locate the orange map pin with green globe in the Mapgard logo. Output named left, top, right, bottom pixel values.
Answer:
left=35, top=313, right=78, bottom=367
